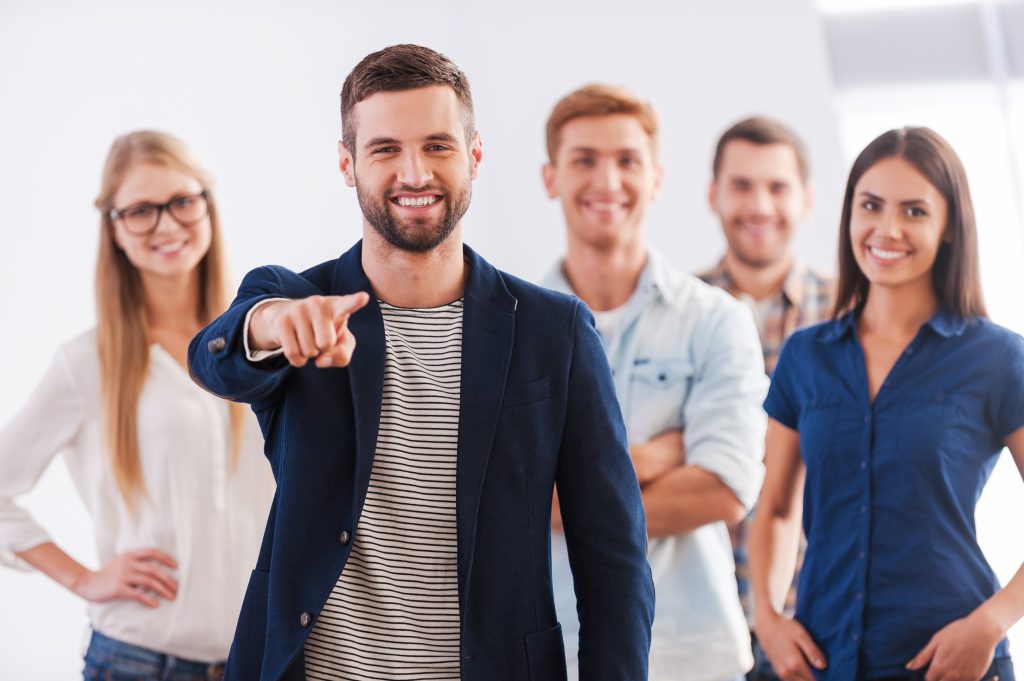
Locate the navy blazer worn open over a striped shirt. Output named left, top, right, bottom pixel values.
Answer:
left=188, top=243, right=654, bottom=681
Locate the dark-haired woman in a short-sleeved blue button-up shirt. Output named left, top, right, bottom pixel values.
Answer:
left=751, top=128, right=1024, bottom=681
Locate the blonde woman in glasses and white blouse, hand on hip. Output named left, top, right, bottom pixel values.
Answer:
left=0, top=131, right=273, bottom=681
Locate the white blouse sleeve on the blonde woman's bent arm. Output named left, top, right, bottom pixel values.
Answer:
left=0, top=352, right=85, bottom=569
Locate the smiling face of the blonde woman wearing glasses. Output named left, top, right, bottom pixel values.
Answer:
left=113, top=163, right=213, bottom=279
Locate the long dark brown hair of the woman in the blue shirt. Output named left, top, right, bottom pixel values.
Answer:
left=833, top=128, right=988, bottom=318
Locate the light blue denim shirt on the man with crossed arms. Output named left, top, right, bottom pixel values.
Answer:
left=544, top=252, right=768, bottom=681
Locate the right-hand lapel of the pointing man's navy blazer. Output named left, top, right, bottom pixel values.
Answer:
left=456, top=247, right=516, bottom=612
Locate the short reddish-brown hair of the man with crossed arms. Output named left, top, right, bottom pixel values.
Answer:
left=547, top=83, right=658, bottom=163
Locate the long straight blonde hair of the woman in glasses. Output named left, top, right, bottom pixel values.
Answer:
left=95, top=130, right=244, bottom=509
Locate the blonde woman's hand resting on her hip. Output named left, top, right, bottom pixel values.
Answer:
left=72, top=549, right=178, bottom=607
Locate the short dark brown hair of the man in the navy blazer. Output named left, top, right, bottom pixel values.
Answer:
left=341, top=45, right=476, bottom=156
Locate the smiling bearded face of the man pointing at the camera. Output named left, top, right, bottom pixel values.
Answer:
left=339, top=85, right=482, bottom=253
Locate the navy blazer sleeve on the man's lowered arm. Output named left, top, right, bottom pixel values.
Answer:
left=556, top=302, right=654, bottom=681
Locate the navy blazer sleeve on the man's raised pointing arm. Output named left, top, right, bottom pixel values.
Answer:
left=188, top=261, right=323, bottom=411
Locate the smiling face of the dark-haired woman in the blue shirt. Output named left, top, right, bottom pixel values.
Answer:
left=850, top=157, right=947, bottom=290
